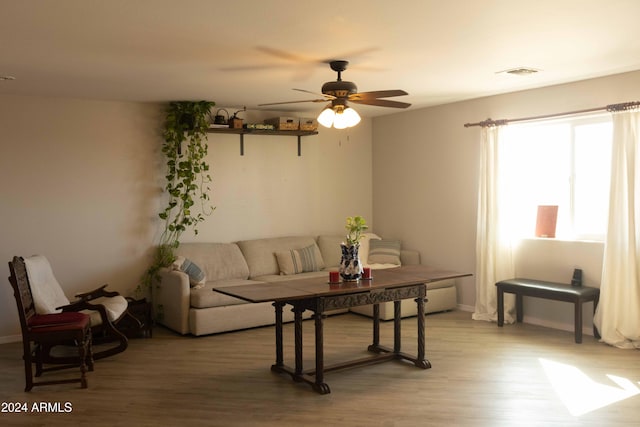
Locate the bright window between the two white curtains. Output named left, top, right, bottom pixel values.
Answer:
left=500, top=115, right=612, bottom=240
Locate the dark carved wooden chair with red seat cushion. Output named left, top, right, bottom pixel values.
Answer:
left=9, top=257, right=93, bottom=391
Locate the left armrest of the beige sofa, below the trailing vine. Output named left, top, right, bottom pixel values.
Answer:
left=151, top=268, right=191, bottom=335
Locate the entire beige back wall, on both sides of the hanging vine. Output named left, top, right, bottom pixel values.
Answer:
left=0, top=96, right=373, bottom=342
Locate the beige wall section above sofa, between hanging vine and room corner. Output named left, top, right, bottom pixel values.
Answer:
left=178, top=107, right=373, bottom=242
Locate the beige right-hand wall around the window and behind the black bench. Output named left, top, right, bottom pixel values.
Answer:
left=373, top=72, right=640, bottom=336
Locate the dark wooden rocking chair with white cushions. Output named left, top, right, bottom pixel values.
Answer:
left=24, top=255, right=139, bottom=363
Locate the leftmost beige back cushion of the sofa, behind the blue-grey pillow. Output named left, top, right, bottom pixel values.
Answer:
left=176, top=243, right=249, bottom=281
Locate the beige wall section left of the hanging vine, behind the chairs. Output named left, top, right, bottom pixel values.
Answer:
left=0, top=96, right=160, bottom=340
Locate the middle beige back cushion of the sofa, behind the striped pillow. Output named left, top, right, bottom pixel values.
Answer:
left=237, top=236, right=324, bottom=278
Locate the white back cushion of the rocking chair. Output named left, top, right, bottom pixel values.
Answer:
left=24, top=255, right=69, bottom=314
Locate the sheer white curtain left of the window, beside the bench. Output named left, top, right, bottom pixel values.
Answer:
left=473, top=126, right=515, bottom=323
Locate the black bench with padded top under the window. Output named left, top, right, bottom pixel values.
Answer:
left=496, top=279, right=600, bottom=344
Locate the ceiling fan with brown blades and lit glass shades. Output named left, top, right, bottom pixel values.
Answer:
left=258, top=60, right=411, bottom=129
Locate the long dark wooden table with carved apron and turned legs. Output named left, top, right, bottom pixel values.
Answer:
left=214, top=265, right=470, bottom=394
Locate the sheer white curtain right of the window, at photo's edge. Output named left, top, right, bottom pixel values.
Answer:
left=594, top=109, right=640, bottom=348
